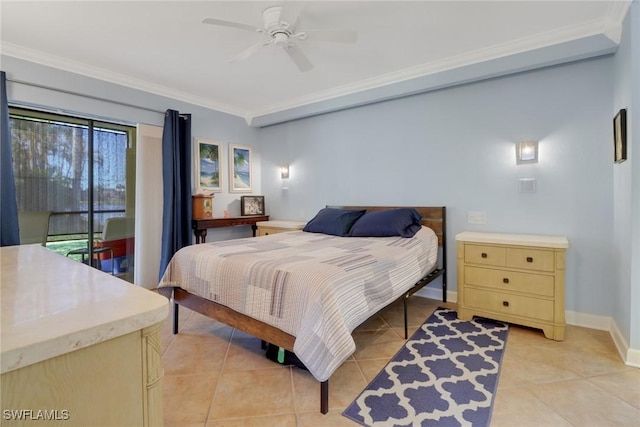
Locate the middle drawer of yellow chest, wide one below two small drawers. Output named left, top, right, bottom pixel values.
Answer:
left=464, top=266, right=554, bottom=297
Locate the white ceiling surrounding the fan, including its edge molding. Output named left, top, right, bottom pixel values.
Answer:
left=0, top=0, right=629, bottom=126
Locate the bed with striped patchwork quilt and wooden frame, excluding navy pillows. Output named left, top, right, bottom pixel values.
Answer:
left=159, top=206, right=446, bottom=413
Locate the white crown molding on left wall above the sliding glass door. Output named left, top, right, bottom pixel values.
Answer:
left=0, top=42, right=245, bottom=118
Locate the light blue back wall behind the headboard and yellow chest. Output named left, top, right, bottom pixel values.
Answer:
left=260, top=57, right=615, bottom=316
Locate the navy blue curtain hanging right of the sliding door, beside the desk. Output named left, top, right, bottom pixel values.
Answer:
left=159, top=110, right=192, bottom=278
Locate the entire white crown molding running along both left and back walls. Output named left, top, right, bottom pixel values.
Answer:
left=1, top=5, right=631, bottom=127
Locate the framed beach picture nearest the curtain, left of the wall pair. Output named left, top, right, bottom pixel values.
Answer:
left=193, top=138, right=222, bottom=191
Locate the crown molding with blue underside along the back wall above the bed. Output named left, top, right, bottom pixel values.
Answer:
left=247, top=18, right=621, bottom=127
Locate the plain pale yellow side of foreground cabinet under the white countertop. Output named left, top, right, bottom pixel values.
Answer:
left=2, top=331, right=146, bottom=427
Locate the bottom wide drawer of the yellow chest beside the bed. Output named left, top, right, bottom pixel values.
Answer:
left=464, top=288, right=554, bottom=322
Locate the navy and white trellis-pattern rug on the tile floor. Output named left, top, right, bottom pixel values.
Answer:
left=342, top=308, right=509, bottom=427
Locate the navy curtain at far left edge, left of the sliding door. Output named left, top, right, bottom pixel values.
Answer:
left=0, top=71, right=20, bottom=246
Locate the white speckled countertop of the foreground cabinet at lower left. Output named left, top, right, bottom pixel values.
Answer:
left=0, top=245, right=169, bottom=373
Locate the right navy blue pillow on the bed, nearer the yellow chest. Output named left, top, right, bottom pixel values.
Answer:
left=349, top=208, right=422, bottom=237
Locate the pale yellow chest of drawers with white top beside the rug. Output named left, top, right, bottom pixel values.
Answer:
left=456, top=232, right=569, bottom=341
